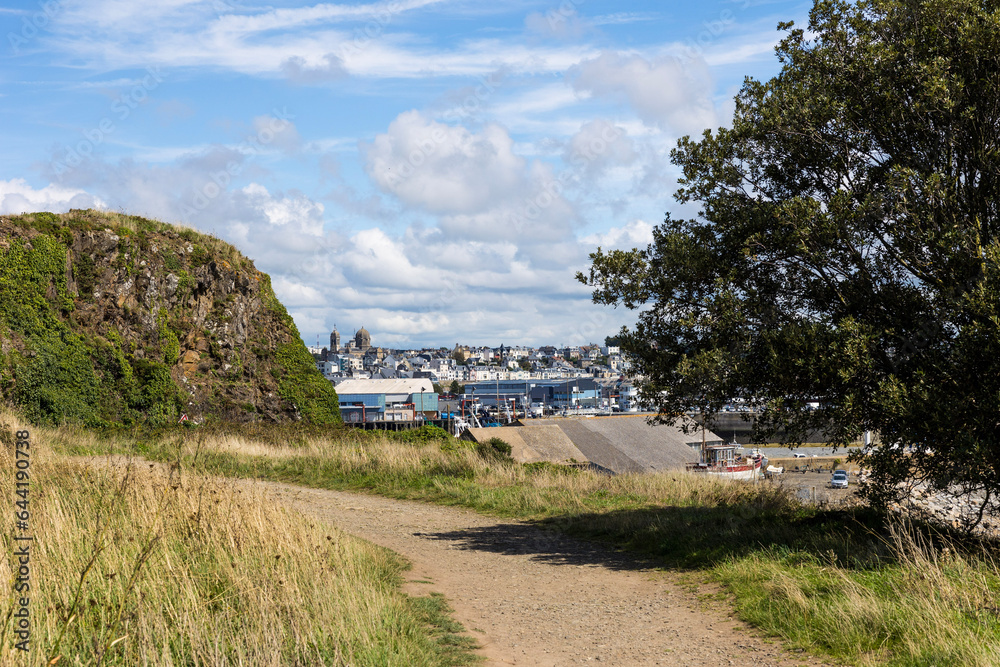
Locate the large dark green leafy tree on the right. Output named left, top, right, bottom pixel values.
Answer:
left=578, top=0, right=1000, bottom=521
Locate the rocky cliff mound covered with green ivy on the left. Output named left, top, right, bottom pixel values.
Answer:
left=0, top=210, right=340, bottom=426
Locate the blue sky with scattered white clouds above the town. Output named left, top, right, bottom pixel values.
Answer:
left=0, top=0, right=810, bottom=347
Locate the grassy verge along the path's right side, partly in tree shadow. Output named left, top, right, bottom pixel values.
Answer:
left=35, top=422, right=1000, bottom=667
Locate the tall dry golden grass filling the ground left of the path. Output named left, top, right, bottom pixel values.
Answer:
left=0, top=416, right=476, bottom=667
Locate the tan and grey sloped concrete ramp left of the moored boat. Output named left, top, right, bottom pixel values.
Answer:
left=465, top=415, right=722, bottom=474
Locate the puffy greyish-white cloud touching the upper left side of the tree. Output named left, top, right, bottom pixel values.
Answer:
left=568, top=52, right=718, bottom=134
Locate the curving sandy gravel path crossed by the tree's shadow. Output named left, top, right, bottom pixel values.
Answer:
left=259, top=482, right=826, bottom=667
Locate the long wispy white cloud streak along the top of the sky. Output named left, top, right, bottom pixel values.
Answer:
left=45, top=0, right=595, bottom=83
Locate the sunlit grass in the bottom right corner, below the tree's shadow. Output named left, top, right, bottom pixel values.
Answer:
left=716, top=522, right=1000, bottom=667
